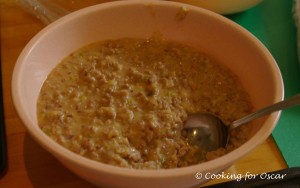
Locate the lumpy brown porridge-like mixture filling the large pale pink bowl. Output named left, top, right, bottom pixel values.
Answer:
left=38, top=38, right=251, bottom=169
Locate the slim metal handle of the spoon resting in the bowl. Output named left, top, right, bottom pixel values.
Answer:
left=230, top=94, right=300, bottom=129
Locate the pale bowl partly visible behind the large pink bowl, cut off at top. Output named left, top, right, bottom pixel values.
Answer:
left=174, top=0, right=262, bottom=14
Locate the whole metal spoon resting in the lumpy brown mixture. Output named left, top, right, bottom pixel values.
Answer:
left=184, top=94, right=300, bottom=151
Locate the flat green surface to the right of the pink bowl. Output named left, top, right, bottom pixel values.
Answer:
left=227, top=0, right=300, bottom=167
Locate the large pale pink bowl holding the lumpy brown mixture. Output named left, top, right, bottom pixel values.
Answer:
left=12, top=0, right=283, bottom=188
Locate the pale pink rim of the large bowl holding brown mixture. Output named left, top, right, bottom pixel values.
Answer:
left=12, top=0, right=284, bottom=179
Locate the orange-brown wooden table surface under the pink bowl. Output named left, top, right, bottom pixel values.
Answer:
left=0, top=0, right=286, bottom=188
